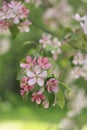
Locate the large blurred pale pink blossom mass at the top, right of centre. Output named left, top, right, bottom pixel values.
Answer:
left=43, top=0, right=72, bottom=30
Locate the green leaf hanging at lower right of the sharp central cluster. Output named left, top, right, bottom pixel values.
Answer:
left=56, top=89, right=65, bottom=109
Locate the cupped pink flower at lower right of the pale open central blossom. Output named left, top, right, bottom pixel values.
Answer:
left=46, top=78, right=58, bottom=93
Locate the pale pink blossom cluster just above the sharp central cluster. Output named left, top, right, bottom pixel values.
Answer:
left=39, top=33, right=62, bottom=60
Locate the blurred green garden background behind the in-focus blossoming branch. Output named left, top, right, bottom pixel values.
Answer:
left=0, top=0, right=87, bottom=130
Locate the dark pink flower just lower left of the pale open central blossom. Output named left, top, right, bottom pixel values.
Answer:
left=20, top=76, right=34, bottom=92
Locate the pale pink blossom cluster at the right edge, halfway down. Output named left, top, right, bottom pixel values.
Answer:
left=71, top=51, right=87, bottom=80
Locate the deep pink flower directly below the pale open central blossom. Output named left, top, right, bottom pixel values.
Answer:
left=31, top=92, right=45, bottom=104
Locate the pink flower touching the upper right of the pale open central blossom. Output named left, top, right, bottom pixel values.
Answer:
left=38, top=57, right=51, bottom=69
